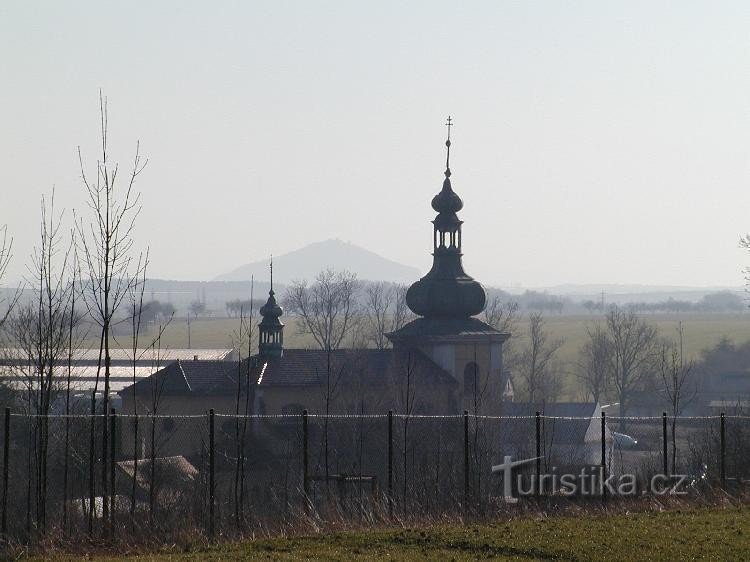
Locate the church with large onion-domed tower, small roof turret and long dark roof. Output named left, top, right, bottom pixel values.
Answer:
left=120, top=124, right=513, bottom=414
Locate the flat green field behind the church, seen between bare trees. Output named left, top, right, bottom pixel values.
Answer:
left=123, top=314, right=750, bottom=400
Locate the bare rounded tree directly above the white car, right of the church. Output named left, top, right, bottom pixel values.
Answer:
left=605, top=306, right=658, bottom=431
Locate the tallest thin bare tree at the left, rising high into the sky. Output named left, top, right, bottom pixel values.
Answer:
left=76, top=92, right=148, bottom=520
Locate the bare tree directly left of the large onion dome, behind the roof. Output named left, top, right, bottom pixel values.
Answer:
left=362, top=281, right=411, bottom=349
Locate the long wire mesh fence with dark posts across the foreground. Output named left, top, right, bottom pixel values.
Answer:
left=2, top=410, right=750, bottom=540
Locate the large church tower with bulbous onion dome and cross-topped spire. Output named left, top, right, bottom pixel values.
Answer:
left=388, top=117, right=510, bottom=406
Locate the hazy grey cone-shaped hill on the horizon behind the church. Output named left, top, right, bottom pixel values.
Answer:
left=214, top=239, right=420, bottom=283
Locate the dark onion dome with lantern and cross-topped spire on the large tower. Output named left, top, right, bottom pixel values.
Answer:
left=406, top=117, right=487, bottom=319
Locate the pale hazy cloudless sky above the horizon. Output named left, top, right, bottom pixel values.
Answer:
left=0, top=0, right=750, bottom=286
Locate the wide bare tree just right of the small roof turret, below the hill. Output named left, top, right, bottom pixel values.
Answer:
left=284, top=269, right=359, bottom=350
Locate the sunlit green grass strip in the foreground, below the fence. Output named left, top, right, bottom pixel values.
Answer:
left=54, top=506, right=750, bottom=561
